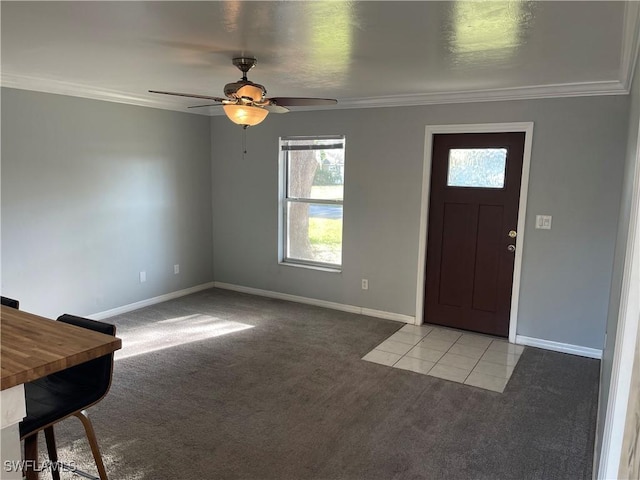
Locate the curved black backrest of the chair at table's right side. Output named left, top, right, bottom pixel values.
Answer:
left=55, top=314, right=116, bottom=404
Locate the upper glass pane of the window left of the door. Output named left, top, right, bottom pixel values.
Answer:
left=287, top=149, right=344, bottom=200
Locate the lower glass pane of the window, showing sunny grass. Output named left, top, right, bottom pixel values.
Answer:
left=286, top=202, right=342, bottom=265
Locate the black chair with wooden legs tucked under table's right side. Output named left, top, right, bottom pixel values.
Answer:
left=20, top=315, right=116, bottom=480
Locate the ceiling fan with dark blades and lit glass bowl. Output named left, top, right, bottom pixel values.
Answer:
left=149, top=57, right=338, bottom=128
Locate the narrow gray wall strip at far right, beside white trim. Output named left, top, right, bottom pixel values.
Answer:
left=594, top=50, right=640, bottom=467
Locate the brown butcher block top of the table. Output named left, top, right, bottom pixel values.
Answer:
left=0, top=306, right=122, bottom=390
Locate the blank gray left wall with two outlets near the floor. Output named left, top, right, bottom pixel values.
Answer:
left=1, top=89, right=213, bottom=316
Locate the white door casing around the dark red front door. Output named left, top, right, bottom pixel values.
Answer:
left=415, top=122, right=533, bottom=343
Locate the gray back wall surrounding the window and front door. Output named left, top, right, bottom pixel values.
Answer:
left=212, top=96, right=628, bottom=349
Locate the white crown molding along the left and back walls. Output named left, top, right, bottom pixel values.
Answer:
left=0, top=74, right=633, bottom=116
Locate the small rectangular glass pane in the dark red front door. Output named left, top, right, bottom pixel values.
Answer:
left=447, top=148, right=507, bottom=188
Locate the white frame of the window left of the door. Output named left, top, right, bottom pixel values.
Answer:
left=278, top=135, right=346, bottom=273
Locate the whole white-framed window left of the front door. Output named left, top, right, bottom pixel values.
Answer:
left=280, top=136, right=345, bottom=269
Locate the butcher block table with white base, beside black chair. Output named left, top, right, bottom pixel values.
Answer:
left=0, top=306, right=122, bottom=480
